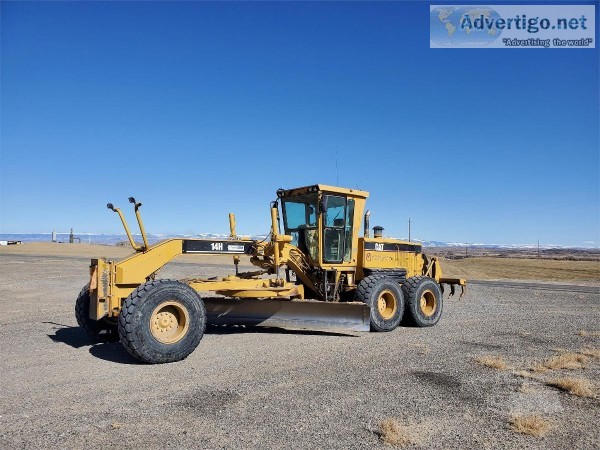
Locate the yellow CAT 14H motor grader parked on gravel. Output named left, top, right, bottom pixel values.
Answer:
left=75, top=185, right=466, bottom=363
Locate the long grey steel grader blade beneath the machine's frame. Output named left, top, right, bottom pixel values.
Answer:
left=204, top=298, right=370, bottom=331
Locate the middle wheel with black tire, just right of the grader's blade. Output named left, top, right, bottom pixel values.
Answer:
left=356, top=275, right=404, bottom=331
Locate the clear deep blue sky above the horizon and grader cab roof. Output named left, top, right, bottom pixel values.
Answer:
left=0, top=1, right=600, bottom=247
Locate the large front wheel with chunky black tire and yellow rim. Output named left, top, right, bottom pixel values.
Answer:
left=119, top=280, right=206, bottom=364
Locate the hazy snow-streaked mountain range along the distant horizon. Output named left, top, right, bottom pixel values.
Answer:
left=0, top=232, right=598, bottom=249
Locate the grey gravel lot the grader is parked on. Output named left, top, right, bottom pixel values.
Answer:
left=0, top=254, right=600, bottom=449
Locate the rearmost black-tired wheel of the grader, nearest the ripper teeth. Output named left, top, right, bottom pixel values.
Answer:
left=402, top=277, right=443, bottom=327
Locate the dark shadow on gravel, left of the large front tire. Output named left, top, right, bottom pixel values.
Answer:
left=43, top=322, right=138, bottom=365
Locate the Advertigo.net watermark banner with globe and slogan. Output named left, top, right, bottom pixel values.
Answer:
left=429, top=5, right=596, bottom=48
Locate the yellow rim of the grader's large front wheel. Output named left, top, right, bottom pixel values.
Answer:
left=150, top=301, right=190, bottom=344
